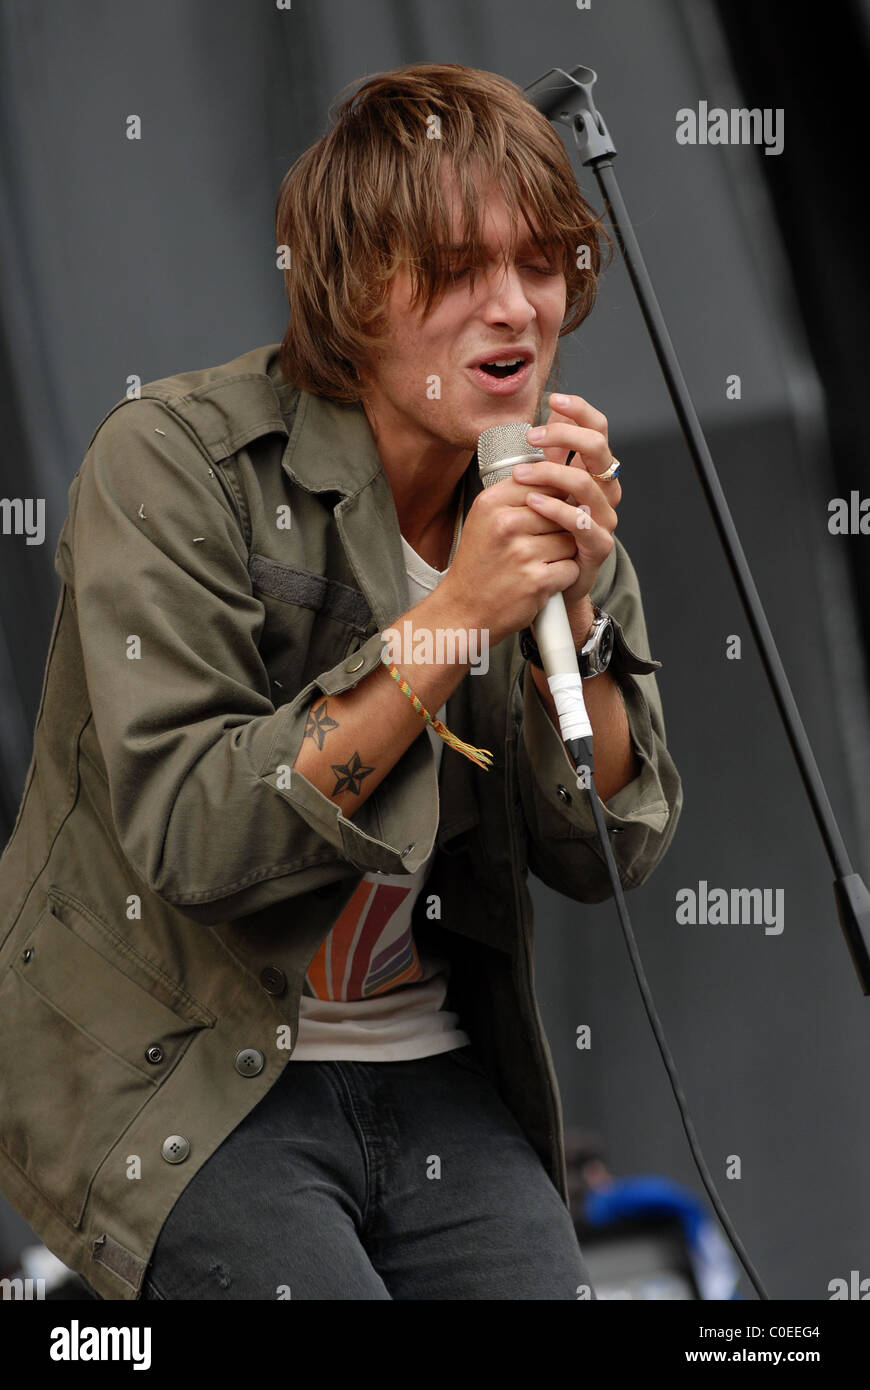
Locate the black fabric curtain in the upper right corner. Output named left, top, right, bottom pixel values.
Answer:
left=716, top=0, right=870, bottom=649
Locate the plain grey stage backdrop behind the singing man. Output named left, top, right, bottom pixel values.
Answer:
left=0, top=0, right=870, bottom=1300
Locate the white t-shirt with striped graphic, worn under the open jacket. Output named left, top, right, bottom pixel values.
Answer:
left=290, top=523, right=471, bottom=1062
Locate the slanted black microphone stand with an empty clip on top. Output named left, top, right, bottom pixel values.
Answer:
left=524, top=67, right=870, bottom=995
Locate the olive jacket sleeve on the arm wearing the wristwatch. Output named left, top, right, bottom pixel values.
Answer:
left=517, top=538, right=682, bottom=902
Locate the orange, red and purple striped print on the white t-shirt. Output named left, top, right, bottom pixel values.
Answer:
left=306, top=874, right=422, bottom=999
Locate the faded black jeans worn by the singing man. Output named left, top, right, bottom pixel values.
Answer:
left=142, top=1047, right=595, bottom=1300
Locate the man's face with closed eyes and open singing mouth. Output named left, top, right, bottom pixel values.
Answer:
left=354, top=166, right=567, bottom=453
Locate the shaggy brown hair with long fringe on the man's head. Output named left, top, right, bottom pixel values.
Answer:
left=275, top=63, right=613, bottom=402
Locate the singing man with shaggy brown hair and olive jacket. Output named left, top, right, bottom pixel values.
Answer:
left=0, top=64, right=681, bottom=1300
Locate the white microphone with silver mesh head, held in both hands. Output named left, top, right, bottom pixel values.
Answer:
left=477, top=421, right=592, bottom=773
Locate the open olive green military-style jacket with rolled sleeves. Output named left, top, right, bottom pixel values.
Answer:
left=0, top=345, right=682, bottom=1300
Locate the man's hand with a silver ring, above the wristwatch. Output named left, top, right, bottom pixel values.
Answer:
left=513, top=393, right=623, bottom=613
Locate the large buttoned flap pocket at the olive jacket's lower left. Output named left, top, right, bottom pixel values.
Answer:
left=0, top=902, right=208, bottom=1226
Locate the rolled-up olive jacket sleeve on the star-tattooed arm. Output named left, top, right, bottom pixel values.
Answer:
left=64, top=399, right=438, bottom=923
